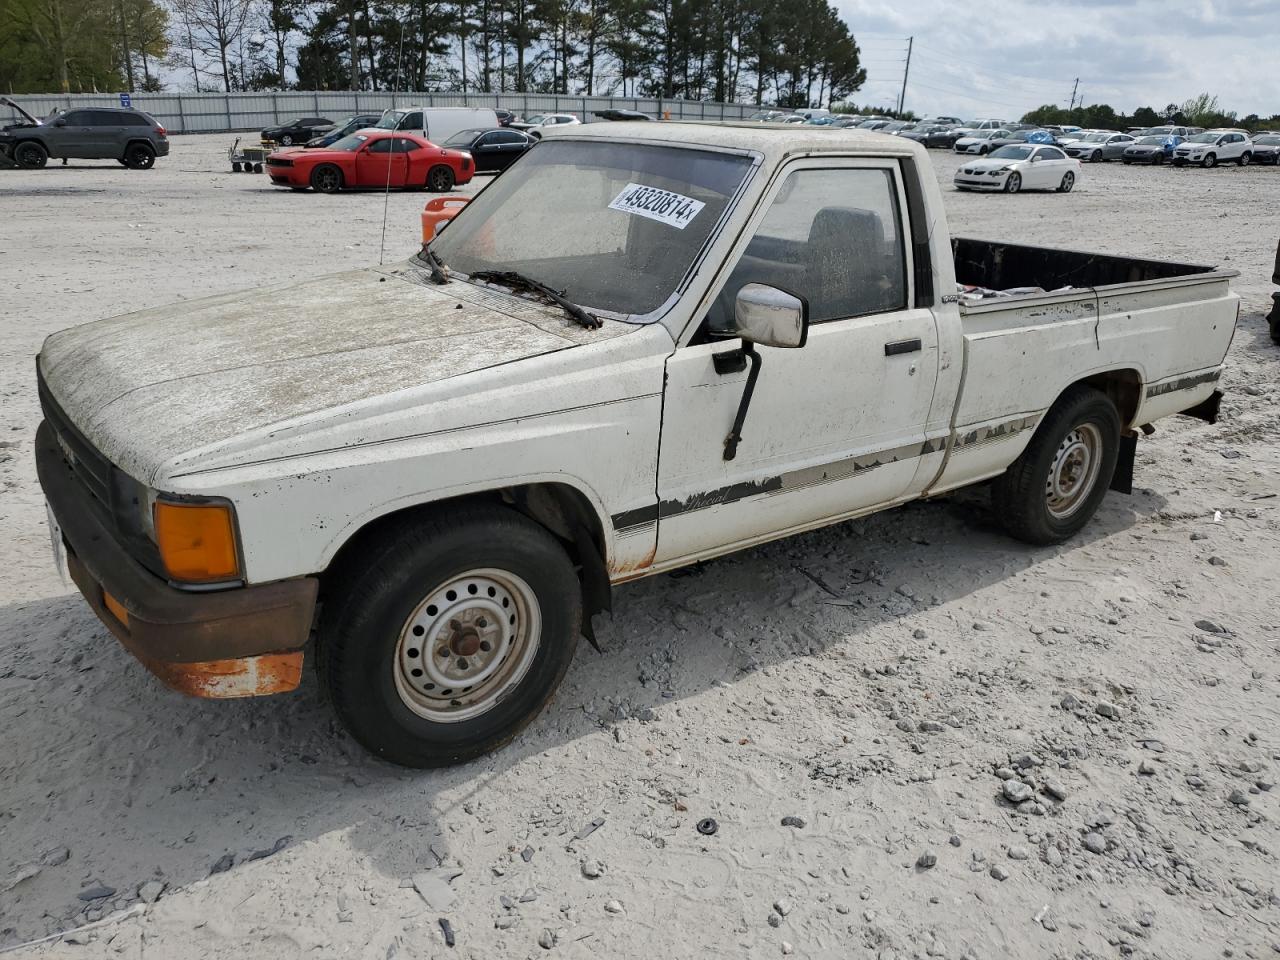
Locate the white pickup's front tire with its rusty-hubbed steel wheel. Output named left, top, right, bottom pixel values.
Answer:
left=319, top=504, right=582, bottom=768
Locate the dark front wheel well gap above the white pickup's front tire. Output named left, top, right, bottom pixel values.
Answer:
left=320, top=483, right=611, bottom=619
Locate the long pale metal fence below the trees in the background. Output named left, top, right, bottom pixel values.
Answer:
left=0, top=91, right=759, bottom=133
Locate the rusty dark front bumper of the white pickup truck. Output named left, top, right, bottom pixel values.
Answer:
left=36, top=421, right=319, bottom=698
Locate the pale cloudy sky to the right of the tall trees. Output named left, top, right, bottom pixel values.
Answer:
left=833, top=0, right=1280, bottom=119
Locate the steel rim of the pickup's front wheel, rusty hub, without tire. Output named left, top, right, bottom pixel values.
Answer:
left=393, top=567, right=543, bottom=723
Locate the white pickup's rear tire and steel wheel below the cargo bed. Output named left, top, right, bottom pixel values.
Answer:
left=991, top=385, right=1120, bottom=545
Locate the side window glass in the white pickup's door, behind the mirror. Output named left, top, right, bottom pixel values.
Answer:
left=708, top=169, right=906, bottom=332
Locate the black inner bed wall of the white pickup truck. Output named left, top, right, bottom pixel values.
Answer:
left=951, top=237, right=1217, bottom=291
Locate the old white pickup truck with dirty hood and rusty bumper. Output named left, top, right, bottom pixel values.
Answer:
left=37, top=123, right=1238, bottom=767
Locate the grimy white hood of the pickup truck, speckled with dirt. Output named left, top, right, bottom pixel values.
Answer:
left=38, top=261, right=637, bottom=484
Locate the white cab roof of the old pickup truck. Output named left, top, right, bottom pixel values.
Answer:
left=543, top=120, right=924, bottom=160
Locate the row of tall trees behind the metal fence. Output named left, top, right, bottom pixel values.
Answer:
left=0, top=0, right=867, bottom=108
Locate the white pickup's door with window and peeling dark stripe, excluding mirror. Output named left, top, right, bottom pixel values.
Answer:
left=654, top=160, right=938, bottom=562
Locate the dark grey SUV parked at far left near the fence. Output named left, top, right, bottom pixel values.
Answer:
left=0, top=97, right=169, bottom=170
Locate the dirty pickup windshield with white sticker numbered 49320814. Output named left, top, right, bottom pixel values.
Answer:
left=431, top=141, right=751, bottom=317
